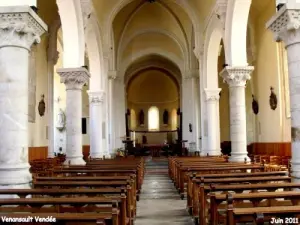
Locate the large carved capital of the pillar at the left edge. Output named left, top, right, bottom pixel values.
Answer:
left=0, top=6, right=48, bottom=50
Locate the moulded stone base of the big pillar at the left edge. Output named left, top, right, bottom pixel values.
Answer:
left=0, top=163, right=32, bottom=189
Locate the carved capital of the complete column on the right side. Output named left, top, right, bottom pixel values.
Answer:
left=220, top=66, right=254, bottom=87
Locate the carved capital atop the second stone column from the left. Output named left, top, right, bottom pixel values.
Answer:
left=57, top=67, right=90, bottom=90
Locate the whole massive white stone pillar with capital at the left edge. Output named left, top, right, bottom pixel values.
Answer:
left=0, top=6, right=47, bottom=188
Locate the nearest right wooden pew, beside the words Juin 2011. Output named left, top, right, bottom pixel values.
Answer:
left=210, top=191, right=300, bottom=225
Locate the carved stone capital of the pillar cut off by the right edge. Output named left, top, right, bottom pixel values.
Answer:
left=266, top=3, right=300, bottom=45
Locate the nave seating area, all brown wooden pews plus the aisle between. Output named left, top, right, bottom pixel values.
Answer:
left=0, top=156, right=300, bottom=225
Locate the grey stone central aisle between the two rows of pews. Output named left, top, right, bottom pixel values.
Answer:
left=135, top=158, right=194, bottom=225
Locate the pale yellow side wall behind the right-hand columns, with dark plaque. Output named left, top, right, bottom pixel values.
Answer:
left=252, top=1, right=290, bottom=142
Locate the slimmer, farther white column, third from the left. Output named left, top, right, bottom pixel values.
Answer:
left=88, top=91, right=104, bottom=158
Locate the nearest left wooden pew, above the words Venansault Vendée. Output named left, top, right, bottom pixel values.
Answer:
left=0, top=197, right=120, bottom=225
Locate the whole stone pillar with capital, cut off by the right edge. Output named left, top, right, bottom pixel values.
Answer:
left=267, top=1, right=300, bottom=179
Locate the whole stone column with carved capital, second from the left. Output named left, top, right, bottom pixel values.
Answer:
left=57, top=67, right=90, bottom=165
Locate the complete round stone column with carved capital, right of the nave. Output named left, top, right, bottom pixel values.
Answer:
left=221, top=66, right=254, bottom=162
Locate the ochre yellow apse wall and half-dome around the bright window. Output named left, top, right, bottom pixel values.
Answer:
left=127, top=70, right=179, bottom=143
